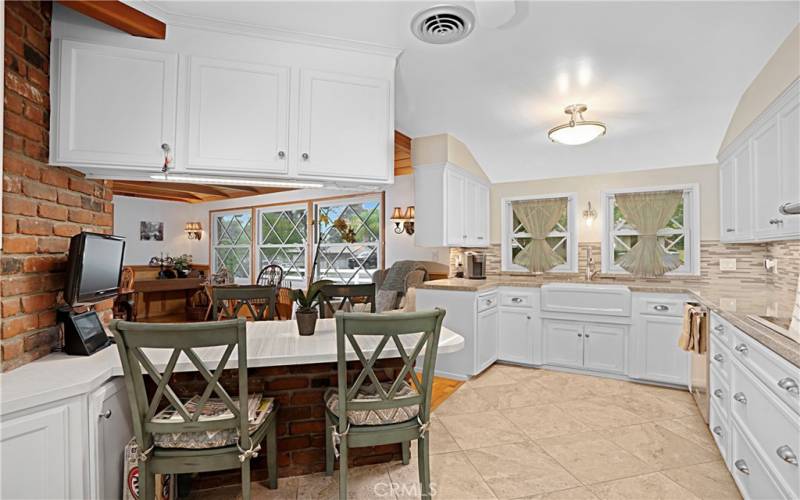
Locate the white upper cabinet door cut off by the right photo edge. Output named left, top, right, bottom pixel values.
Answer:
left=775, top=100, right=800, bottom=236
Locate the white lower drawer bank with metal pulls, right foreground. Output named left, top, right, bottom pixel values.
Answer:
left=709, top=314, right=800, bottom=500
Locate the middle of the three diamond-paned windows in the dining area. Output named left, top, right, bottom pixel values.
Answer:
left=256, top=204, right=308, bottom=288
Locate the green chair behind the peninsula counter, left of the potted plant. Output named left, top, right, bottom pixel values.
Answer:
left=211, top=285, right=277, bottom=321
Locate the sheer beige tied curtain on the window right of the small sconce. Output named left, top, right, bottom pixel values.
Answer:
left=615, top=191, right=683, bottom=278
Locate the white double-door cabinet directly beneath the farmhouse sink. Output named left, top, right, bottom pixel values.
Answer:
left=542, top=319, right=627, bottom=373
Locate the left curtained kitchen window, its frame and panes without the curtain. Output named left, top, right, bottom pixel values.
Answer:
left=501, top=194, right=578, bottom=272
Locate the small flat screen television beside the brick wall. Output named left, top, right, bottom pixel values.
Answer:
left=64, top=232, right=125, bottom=306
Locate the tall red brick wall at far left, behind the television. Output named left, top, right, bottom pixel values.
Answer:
left=0, top=1, right=113, bottom=371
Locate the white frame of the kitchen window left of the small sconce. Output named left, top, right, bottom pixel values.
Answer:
left=500, top=193, right=578, bottom=273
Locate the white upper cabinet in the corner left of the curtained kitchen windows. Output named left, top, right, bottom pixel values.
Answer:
left=414, top=163, right=489, bottom=247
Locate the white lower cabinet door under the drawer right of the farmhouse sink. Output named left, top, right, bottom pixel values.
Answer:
left=636, top=315, right=689, bottom=385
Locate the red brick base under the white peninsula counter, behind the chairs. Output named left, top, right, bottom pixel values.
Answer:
left=170, top=359, right=403, bottom=489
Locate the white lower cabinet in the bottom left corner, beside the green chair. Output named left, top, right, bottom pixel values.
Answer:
left=0, top=378, right=133, bottom=500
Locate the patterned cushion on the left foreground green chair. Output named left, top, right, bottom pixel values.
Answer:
left=153, top=394, right=275, bottom=450
